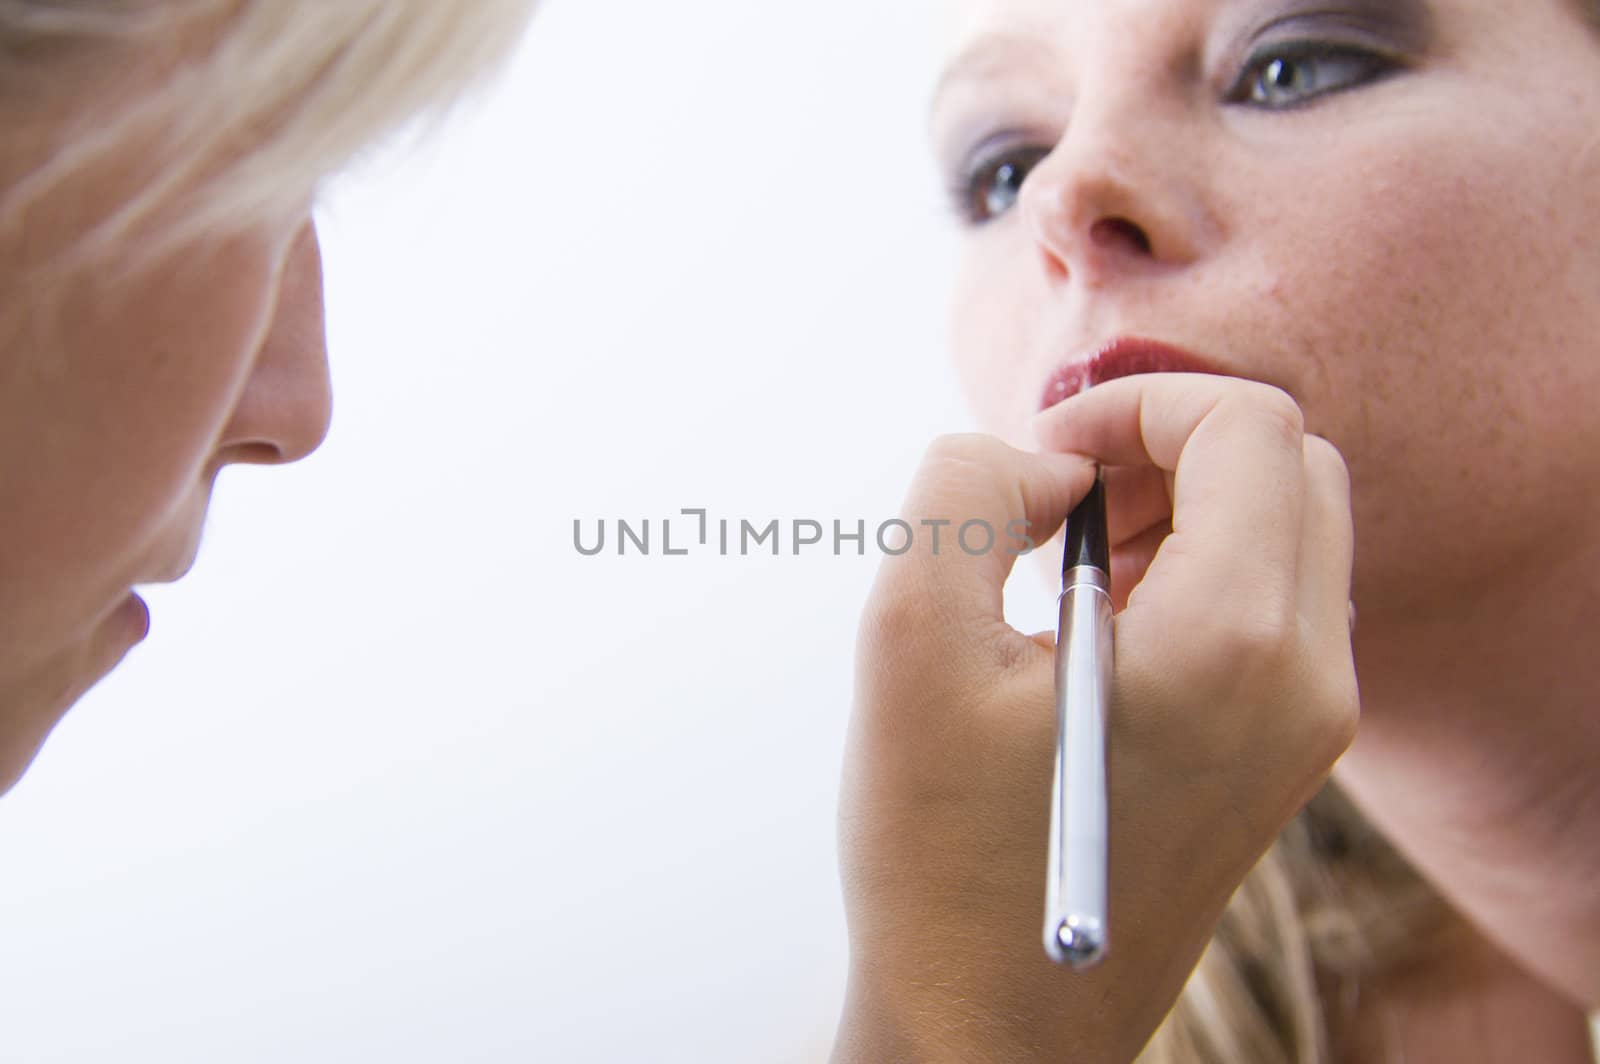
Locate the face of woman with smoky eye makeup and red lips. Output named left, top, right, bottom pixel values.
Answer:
left=933, top=0, right=1600, bottom=617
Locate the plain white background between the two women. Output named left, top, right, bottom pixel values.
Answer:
left=0, top=0, right=1075, bottom=1064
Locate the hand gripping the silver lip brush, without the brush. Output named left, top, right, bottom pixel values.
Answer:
left=834, top=374, right=1360, bottom=1064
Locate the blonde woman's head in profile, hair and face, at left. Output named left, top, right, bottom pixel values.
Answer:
left=0, top=0, right=530, bottom=792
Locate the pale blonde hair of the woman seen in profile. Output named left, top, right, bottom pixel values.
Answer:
left=0, top=0, right=533, bottom=270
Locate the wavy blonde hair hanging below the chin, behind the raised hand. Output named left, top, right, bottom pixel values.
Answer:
left=1138, top=782, right=1466, bottom=1064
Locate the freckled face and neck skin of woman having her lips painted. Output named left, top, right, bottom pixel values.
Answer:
left=934, top=0, right=1600, bottom=1008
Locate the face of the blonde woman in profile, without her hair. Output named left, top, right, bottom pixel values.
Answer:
left=0, top=151, right=330, bottom=792
